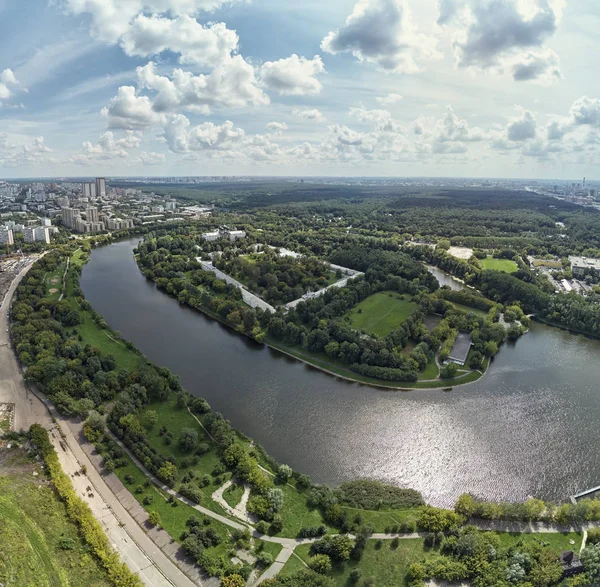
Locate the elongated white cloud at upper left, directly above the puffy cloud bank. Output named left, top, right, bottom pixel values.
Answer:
left=120, top=14, right=238, bottom=67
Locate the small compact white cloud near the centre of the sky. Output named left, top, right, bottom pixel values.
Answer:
left=260, top=54, right=325, bottom=96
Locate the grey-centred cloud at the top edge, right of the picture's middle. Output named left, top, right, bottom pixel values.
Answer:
left=321, top=0, right=438, bottom=73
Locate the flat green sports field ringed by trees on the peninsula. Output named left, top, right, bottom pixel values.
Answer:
left=349, top=291, right=418, bottom=337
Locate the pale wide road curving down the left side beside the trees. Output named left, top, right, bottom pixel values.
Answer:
left=0, top=263, right=202, bottom=587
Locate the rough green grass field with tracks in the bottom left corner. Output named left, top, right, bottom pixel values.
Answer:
left=0, top=449, right=111, bottom=587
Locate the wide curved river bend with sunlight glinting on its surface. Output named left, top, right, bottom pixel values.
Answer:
left=81, top=239, right=600, bottom=506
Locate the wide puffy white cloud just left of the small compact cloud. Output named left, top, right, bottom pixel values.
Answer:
left=137, top=55, right=269, bottom=114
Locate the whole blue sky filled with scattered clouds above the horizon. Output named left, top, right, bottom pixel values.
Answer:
left=0, top=0, right=600, bottom=179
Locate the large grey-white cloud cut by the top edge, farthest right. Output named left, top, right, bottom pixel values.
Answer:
left=438, top=0, right=564, bottom=83
